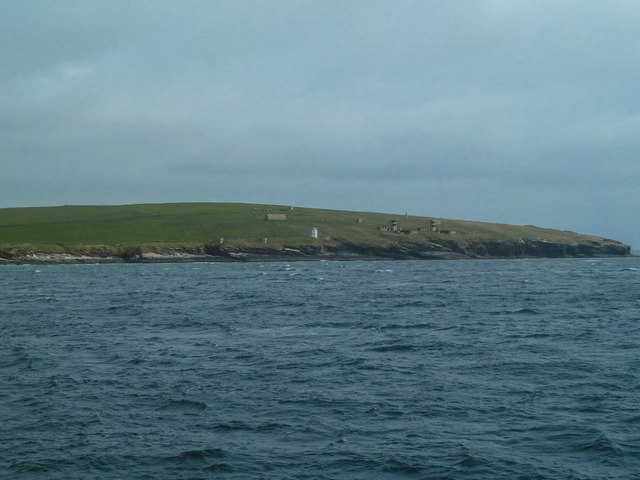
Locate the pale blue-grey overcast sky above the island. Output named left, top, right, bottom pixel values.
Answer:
left=0, top=0, right=640, bottom=248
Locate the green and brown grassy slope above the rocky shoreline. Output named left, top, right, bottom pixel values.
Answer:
left=0, top=203, right=632, bottom=258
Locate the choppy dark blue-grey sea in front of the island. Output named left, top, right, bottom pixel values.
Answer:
left=0, top=258, right=640, bottom=480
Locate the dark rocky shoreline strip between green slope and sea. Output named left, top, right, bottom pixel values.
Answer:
left=0, top=239, right=631, bottom=265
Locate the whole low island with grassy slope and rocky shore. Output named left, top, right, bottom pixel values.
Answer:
left=0, top=203, right=631, bottom=265
